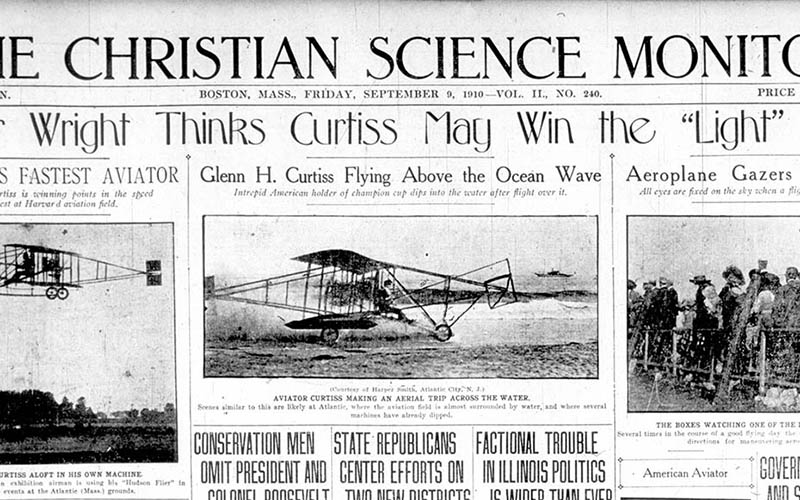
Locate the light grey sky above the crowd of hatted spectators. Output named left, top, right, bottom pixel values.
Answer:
left=628, top=217, right=800, bottom=297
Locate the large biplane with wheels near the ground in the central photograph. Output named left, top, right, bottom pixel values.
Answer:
left=205, top=249, right=517, bottom=344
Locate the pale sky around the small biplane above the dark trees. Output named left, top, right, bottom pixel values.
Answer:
left=0, top=224, right=175, bottom=412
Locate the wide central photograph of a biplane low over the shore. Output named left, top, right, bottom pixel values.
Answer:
left=204, top=216, right=597, bottom=378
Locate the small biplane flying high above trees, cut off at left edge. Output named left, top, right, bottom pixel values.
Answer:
left=0, top=243, right=161, bottom=300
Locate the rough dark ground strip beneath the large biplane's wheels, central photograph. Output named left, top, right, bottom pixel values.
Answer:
left=206, top=339, right=597, bottom=378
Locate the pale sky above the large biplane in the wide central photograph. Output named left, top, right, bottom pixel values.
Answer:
left=204, top=217, right=597, bottom=285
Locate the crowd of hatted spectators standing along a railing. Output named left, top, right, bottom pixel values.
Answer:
left=628, top=263, right=800, bottom=374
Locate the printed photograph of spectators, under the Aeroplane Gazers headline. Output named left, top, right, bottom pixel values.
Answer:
left=627, top=216, right=800, bottom=412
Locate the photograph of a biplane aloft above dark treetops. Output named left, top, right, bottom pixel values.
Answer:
left=0, top=223, right=177, bottom=464
